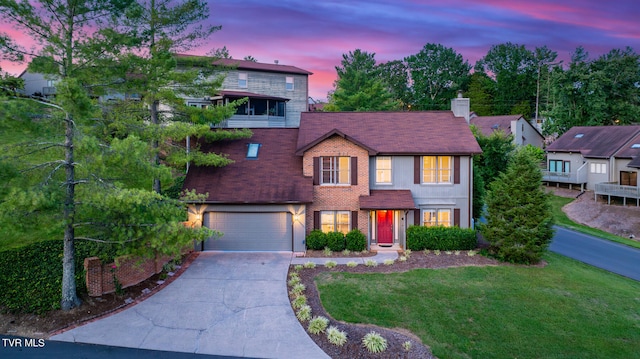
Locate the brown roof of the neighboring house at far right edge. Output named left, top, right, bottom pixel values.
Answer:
left=547, top=126, right=640, bottom=158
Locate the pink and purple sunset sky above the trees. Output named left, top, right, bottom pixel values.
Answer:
left=0, top=0, right=640, bottom=100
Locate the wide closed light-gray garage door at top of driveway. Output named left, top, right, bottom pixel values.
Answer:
left=204, top=212, right=293, bottom=251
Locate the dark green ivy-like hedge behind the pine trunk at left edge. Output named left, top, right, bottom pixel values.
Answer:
left=0, top=240, right=116, bottom=315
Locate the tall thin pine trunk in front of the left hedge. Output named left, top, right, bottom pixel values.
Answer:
left=60, top=114, right=80, bottom=310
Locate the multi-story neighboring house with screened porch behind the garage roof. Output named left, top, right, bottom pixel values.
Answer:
left=178, top=55, right=312, bottom=128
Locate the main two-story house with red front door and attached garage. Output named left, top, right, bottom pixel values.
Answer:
left=184, top=111, right=481, bottom=251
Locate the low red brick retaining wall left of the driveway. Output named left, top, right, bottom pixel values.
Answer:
left=84, top=255, right=176, bottom=297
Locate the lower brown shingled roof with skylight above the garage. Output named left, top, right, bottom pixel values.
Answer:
left=184, top=128, right=313, bottom=204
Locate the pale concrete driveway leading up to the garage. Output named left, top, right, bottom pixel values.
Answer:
left=50, top=252, right=328, bottom=358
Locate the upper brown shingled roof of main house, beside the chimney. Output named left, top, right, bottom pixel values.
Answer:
left=297, top=111, right=481, bottom=155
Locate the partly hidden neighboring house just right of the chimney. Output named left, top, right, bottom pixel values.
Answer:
left=470, top=115, right=544, bottom=148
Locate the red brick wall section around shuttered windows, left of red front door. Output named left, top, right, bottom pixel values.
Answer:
left=302, top=136, right=369, bottom=235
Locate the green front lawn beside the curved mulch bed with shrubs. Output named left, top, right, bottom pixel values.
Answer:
left=316, top=254, right=640, bottom=359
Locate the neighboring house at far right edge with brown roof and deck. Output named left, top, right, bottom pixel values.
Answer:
left=543, top=126, right=640, bottom=202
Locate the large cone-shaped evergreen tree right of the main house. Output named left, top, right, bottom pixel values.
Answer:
left=481, top=150, right=553, bottom=263
